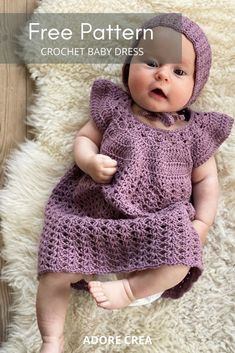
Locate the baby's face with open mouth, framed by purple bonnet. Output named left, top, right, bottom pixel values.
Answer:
left=128, top=27, right=195, bottom=112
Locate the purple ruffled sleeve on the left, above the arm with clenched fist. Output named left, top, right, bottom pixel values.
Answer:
left=90, top=79, right=124, bottom=132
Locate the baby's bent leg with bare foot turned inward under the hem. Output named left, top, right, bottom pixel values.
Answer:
left=89, top=265, right=189, bottom=309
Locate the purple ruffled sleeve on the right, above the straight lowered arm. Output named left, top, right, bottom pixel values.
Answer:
left=192, top=112, right=234, bottom=168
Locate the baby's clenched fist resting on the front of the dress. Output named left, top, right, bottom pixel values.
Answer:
left=87, top=154, right=117, bottom=184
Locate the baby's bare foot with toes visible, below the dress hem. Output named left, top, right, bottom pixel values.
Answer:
left=88, top=279, right=135, bottom=310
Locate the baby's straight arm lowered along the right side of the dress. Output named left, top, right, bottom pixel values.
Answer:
left=192, top=157, right=219, bottom=243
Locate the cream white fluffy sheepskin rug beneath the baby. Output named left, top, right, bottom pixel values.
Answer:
left=0, top=0, right=235, bottom=353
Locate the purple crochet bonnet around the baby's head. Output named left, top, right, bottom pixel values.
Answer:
left=122, top=13, right=211, bottom=106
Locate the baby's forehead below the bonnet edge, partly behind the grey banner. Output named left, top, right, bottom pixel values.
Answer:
left=138, top=26, right=195, bottom=63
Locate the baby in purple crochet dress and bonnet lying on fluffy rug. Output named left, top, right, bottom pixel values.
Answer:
left=37, top=14, right=233, bottom=353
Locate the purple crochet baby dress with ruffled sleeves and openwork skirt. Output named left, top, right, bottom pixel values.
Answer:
left=39, top=80, right=233, bottom=298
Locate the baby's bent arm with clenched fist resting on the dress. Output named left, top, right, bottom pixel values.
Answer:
left=74, top=120, right=117, bottom=184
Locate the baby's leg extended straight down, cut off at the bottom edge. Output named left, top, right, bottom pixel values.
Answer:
left=36, top=273, right=82, bottom=353
